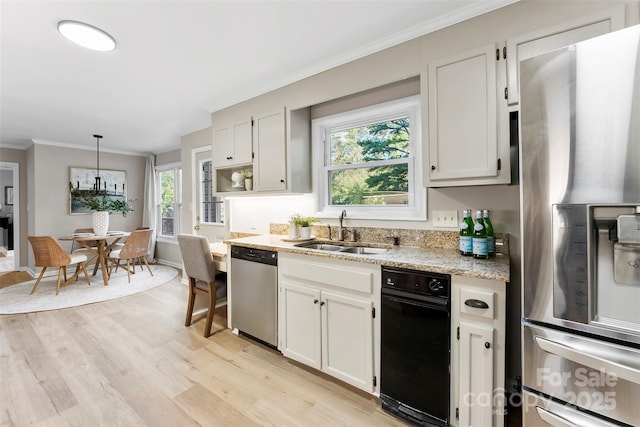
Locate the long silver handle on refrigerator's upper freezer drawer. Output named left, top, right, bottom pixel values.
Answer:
left=535, top=336, right=640, bottom=385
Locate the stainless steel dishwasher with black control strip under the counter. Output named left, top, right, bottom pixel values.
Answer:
left=230, top=246, right=278, bottom=348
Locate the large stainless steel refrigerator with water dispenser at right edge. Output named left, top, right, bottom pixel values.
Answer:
left=520, top=26, right=640, bottom=427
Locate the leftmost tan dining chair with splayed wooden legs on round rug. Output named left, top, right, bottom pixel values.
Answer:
left=27, top=236, right=91, bottom=295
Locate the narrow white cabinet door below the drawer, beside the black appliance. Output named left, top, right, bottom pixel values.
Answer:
left=457, top=321, right=494, bottom=427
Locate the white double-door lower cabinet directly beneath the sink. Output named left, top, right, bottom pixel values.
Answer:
left=278, top=253, right=380, bottom=393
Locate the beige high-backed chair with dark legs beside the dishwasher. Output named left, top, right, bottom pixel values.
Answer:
left=178, top=234, right=227, bottom=338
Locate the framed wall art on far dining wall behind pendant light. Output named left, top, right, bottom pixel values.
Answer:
left=69, top=166, right=127, bottom=214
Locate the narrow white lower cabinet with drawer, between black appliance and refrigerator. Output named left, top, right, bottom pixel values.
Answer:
left=451, top=276, right=506, bottom=427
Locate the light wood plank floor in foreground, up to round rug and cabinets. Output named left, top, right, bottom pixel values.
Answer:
left=0, top=278, right=405, bottom=427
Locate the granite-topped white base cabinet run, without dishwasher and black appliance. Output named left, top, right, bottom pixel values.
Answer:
left=225, top=231, right=510, bottom=426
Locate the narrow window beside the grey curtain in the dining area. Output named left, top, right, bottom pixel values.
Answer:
left=156, top=166, right=182, bottom=239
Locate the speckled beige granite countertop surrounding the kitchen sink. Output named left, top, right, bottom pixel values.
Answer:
left=224, top=234, right=510, bottom=282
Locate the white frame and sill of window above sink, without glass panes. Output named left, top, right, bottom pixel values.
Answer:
left=312, top=95, right=427, bottom=221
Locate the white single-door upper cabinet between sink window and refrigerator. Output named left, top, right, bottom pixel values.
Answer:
left=423, top=43, right=511, bottom=187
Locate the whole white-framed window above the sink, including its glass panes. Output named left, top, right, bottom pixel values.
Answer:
left=313, top=96, right=426, bottom=220
